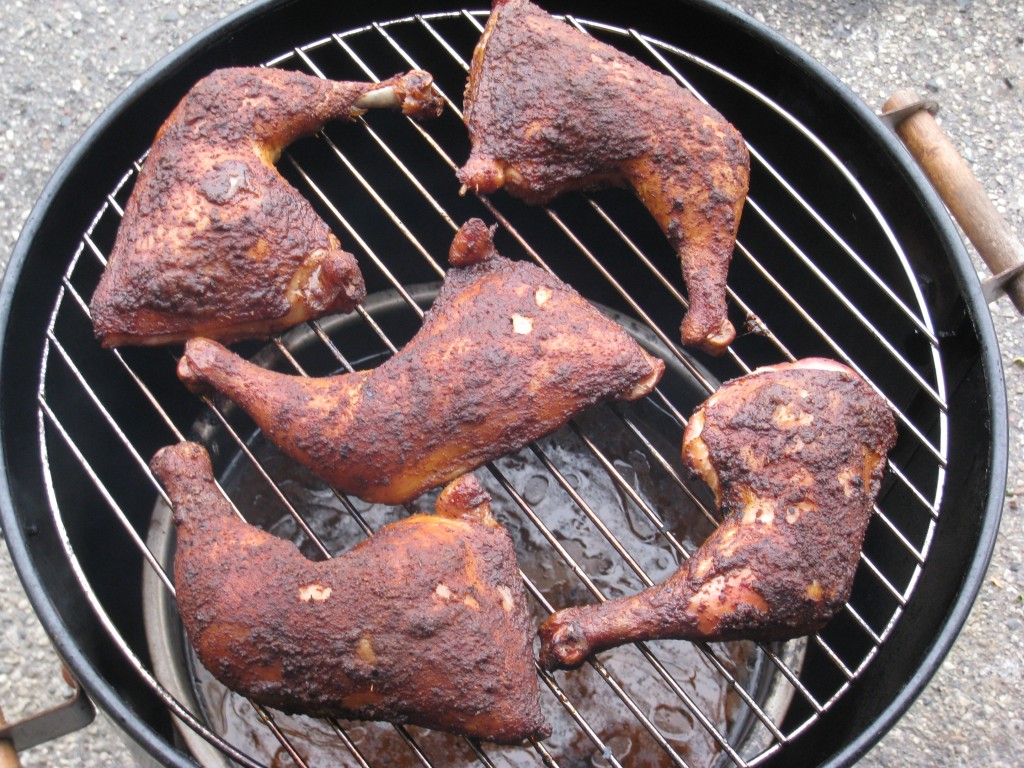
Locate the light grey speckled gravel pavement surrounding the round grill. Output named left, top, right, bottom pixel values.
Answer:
left=0, top=0, right=1024, bottom=768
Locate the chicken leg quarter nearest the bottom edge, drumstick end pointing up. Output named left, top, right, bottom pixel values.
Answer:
left=151, top=442, right=549, bottom=743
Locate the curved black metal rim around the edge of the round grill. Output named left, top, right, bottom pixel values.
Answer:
left=0, top=0, right=1009, bottom=765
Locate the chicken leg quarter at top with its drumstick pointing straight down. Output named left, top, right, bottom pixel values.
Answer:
left=458, top=0, right=750, bottom=354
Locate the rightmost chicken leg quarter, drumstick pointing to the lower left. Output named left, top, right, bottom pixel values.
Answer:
left=541, top=358, right=896, bottom=669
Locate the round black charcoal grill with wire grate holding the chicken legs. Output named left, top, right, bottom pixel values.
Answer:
left=0, top=0, right=1007, bottom=766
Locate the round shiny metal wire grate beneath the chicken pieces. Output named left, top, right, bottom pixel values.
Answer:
left=39, top=11, right=946, bottom=766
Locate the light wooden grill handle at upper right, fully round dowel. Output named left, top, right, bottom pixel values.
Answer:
left=883, top=88, right=1024, bottom=314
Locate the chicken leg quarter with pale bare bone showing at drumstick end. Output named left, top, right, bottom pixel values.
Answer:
left=90, top=69, right=442, bottom=347
